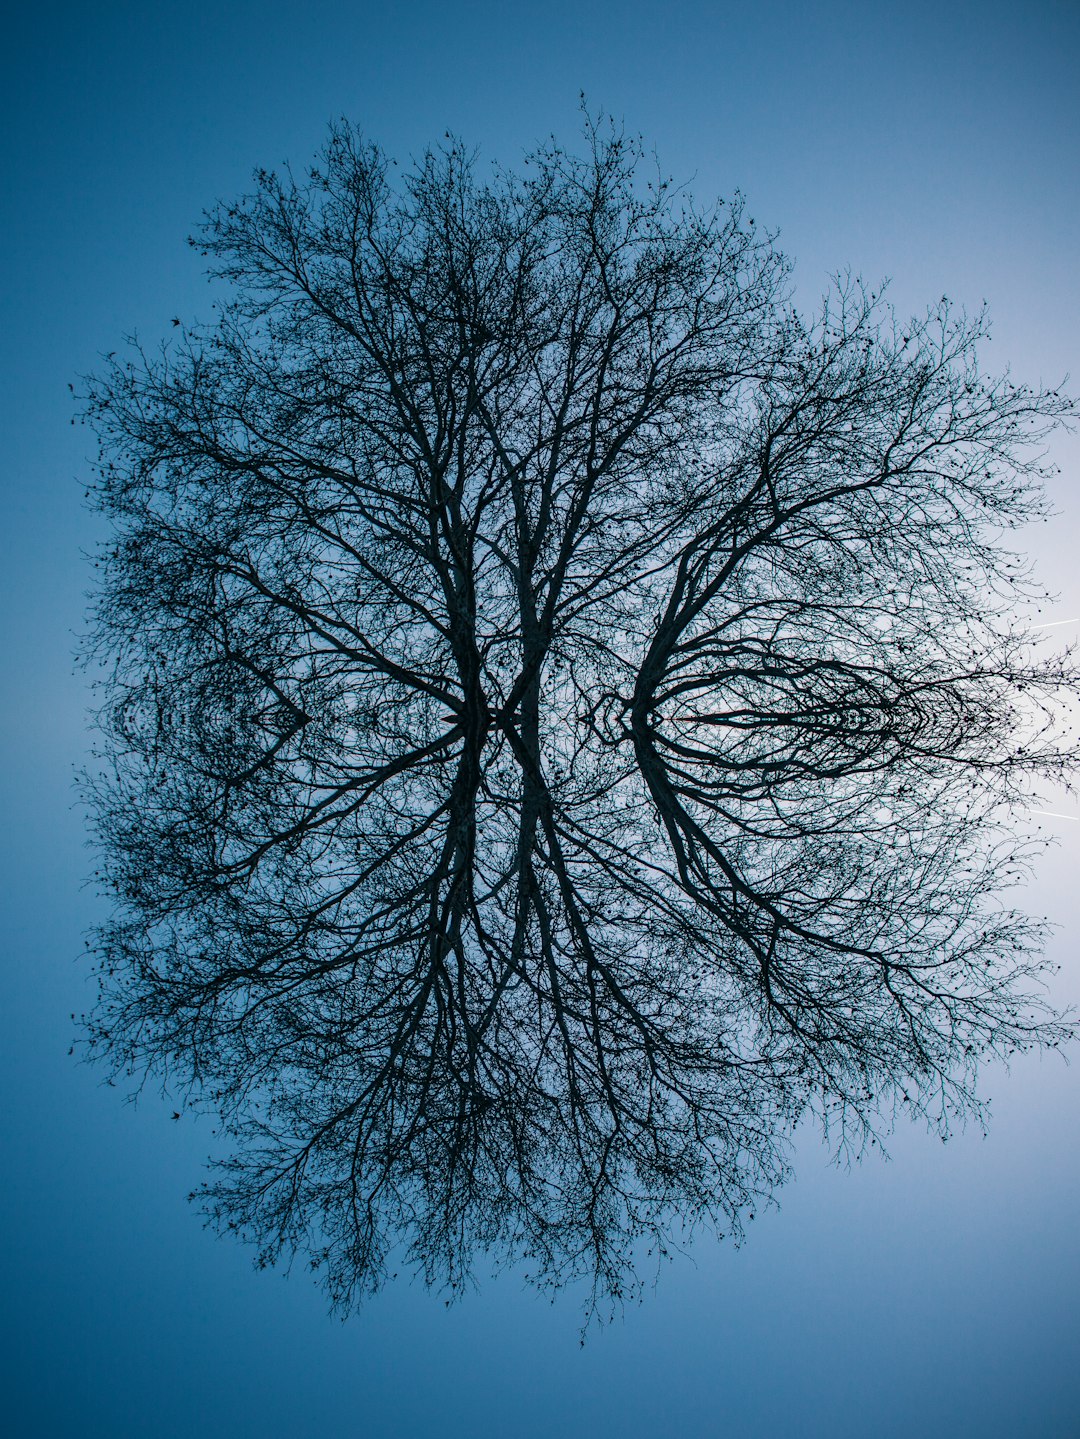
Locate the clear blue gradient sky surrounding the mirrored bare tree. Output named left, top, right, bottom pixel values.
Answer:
left=0, top=0, right=1080, bottom=1439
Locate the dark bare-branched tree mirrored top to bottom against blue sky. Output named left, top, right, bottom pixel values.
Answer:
left=86, top=125, right=1076, bottom=1307
